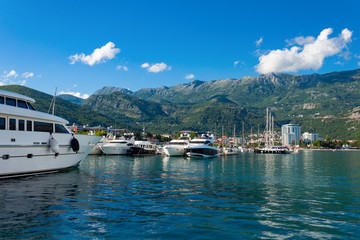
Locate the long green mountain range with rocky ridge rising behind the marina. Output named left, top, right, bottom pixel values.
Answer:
left=1, top=69, right=360, bottom=139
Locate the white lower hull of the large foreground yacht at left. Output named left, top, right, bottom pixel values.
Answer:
left=0, top=131, right=100, bottom=178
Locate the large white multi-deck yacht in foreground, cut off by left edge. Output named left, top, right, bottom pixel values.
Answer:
left=0, top=90, right=100, bottom=178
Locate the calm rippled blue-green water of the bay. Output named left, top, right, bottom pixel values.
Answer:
left=0, top=151, right=360, bottom=239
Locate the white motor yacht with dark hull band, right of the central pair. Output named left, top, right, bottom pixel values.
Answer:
left=186, top=134, right=218, bottom=157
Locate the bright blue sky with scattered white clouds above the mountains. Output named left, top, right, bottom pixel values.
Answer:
left=0, top=0, right=360, bottom=96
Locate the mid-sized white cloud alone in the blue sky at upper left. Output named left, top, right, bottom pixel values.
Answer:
left=69, top=42, right=120, bottom=66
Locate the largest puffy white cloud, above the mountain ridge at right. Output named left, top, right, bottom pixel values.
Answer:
left=255, top=28, right=352, bottom=74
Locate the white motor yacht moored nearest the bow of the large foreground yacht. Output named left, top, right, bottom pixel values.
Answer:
left=99, top=135, right=135, bottom=155
